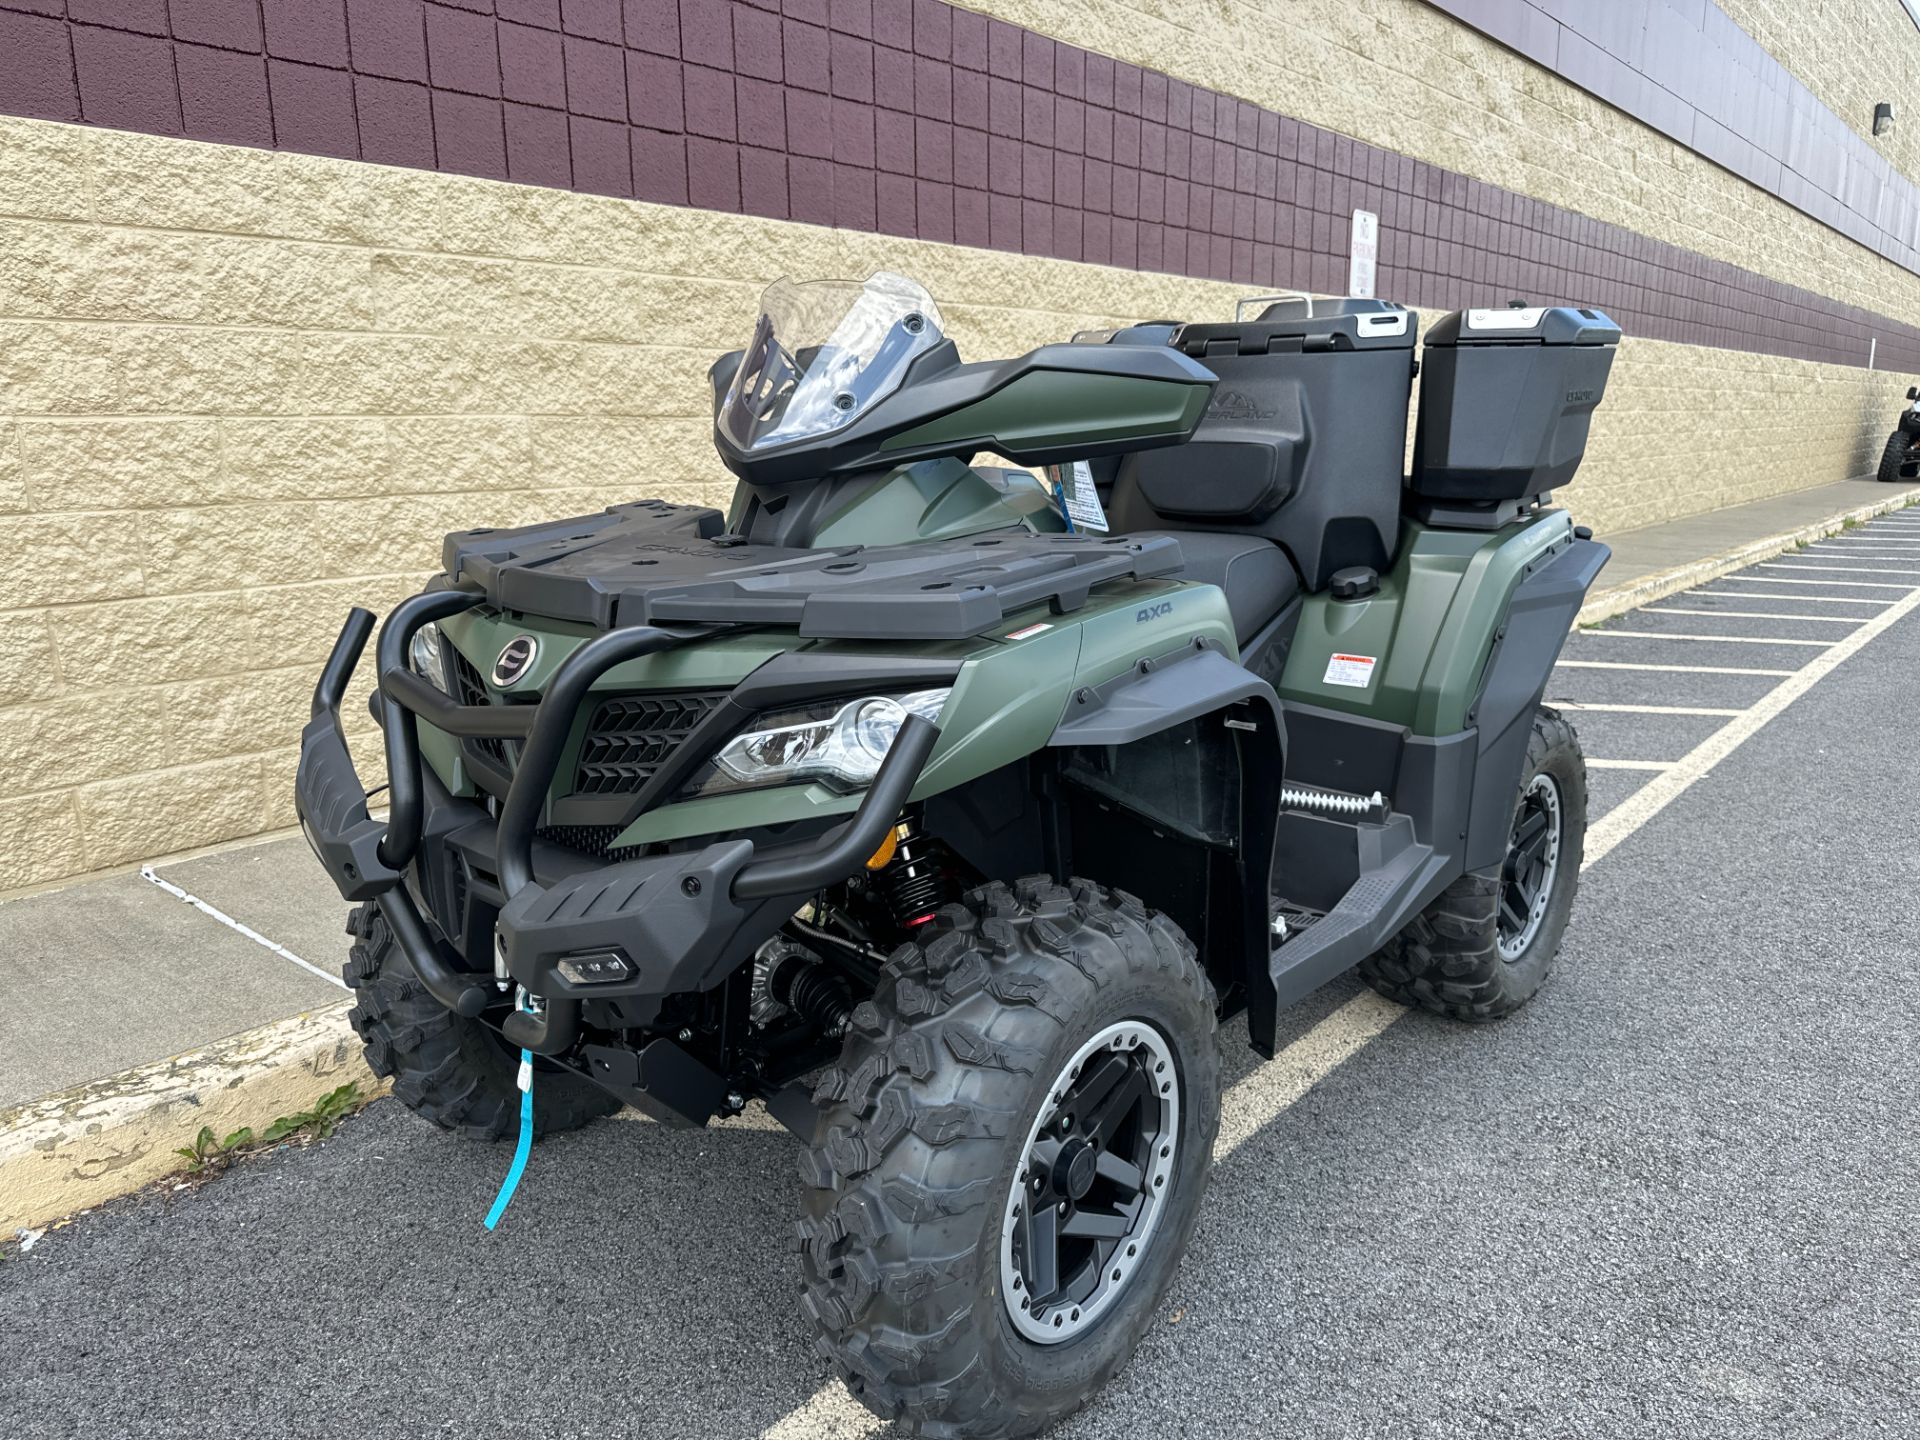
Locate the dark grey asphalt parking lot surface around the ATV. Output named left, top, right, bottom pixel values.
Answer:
left=0, top=513, right=1920, bottom=1440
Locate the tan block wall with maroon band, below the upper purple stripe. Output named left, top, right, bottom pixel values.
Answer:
left=0, top=0, right=1920, bottom=891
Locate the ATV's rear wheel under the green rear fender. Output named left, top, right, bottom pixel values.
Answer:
left=1359, top=705, right=1586, bottom=1021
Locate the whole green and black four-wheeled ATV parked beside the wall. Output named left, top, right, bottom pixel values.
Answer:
left=298, top=275, right=1619, bottom=1436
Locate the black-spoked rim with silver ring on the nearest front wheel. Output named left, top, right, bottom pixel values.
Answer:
left=1000, top=1020, right=1181, bottom=1344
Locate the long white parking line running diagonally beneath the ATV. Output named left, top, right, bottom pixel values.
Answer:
left=760, top=568, right=1920, bottom=1440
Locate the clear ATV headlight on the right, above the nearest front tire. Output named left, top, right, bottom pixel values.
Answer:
left=693, top=689, right=952, bottom=795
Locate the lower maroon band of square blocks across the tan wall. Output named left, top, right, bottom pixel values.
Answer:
left=0, top=0, right=1920, bottom=372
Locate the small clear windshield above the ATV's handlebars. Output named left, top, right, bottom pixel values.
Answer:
left=718, top=271, right=941, bottom=449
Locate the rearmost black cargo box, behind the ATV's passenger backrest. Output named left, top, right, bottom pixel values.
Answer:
left=1409, top=305, right=1620, bottom=505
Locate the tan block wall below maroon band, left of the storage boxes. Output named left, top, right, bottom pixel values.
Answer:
left=0, top=119, right=1282, bottom=891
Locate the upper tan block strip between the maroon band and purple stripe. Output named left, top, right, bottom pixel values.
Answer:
left=970, top=0, right=1920, bottom=332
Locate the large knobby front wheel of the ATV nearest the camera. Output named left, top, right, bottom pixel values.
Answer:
left=799, top=876, right=1219, bottom=1440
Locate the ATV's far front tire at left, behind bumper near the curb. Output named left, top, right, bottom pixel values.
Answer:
left=340, top=900, right=620, bottom=1140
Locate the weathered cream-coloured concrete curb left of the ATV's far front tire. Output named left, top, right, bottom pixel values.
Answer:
left=0, top=1002, right=388, bottom=1236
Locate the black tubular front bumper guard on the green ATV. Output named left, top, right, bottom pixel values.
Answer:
left=294, top=589, right=939, bottom=1054
